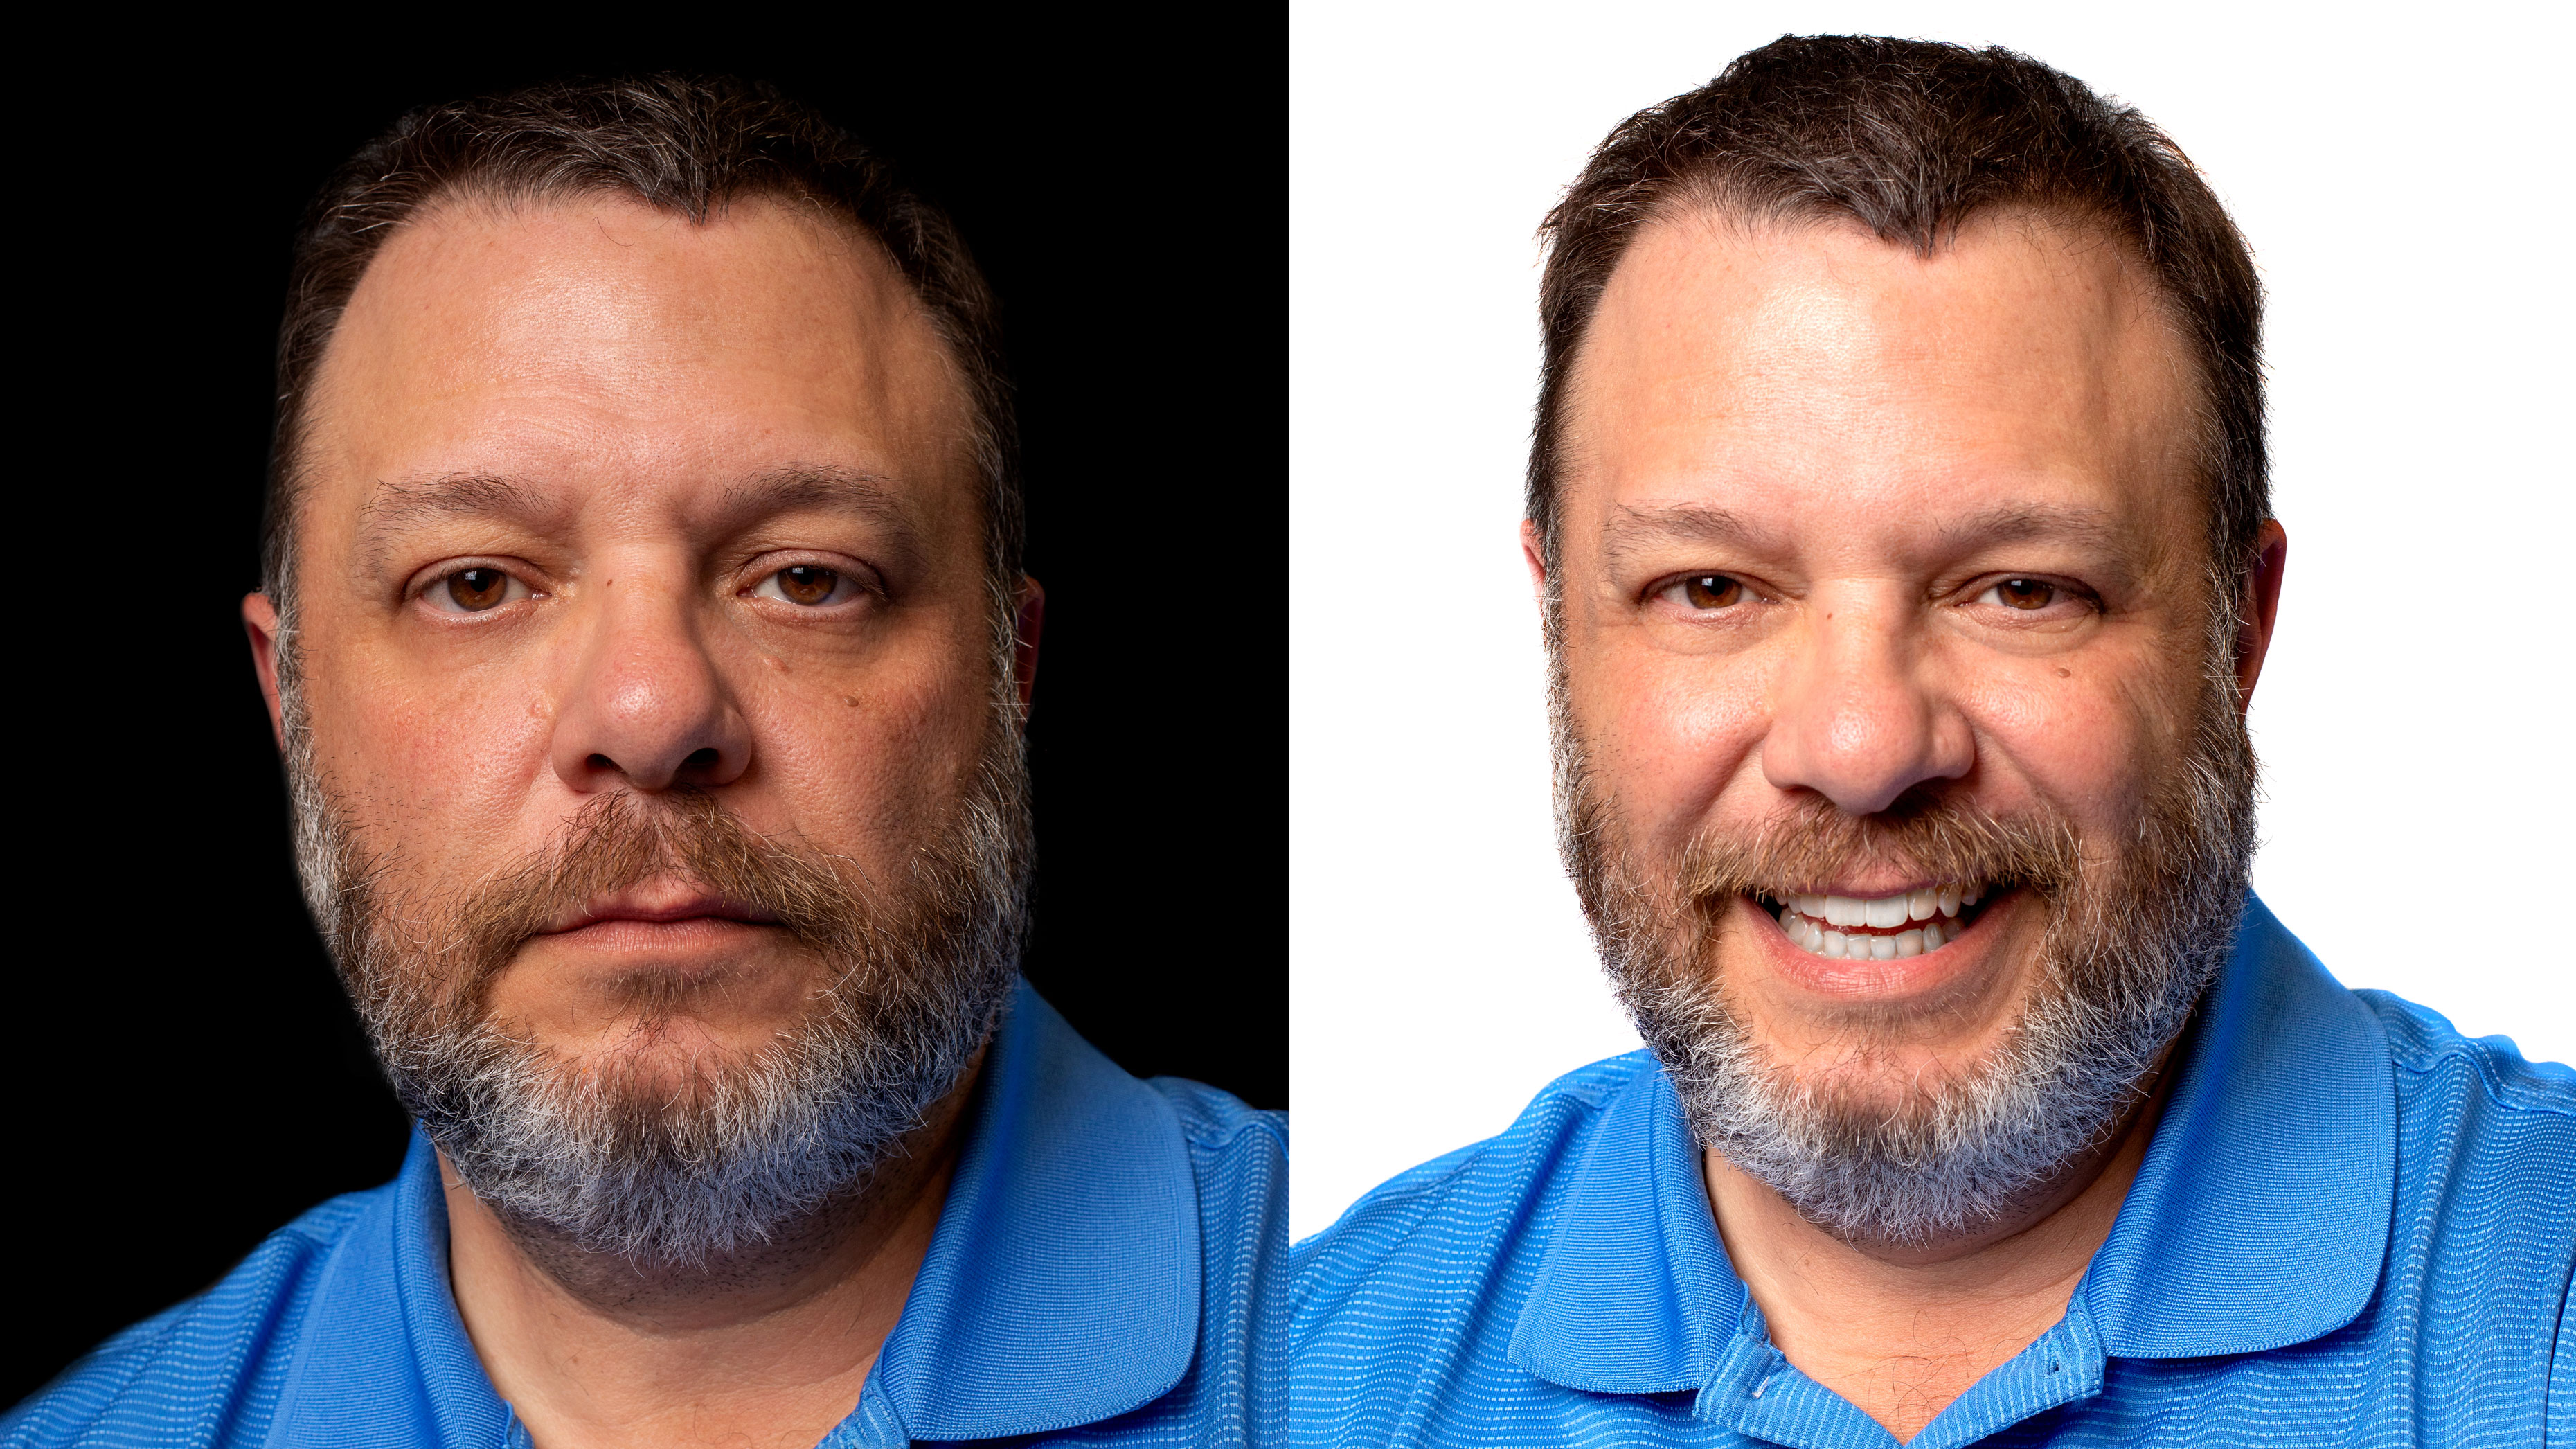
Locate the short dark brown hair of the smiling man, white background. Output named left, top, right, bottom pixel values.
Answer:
left=1528, top=36, right=2272, bottom=578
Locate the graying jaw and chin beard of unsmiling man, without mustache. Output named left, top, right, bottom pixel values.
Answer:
left=289, top=686, right=1030, bottom=1271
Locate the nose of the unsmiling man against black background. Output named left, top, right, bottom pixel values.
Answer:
left=554, top=588, right=752, bottom=794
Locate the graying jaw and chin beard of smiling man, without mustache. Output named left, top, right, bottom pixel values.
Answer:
left=1559, top=655, right=2254, bottom=1248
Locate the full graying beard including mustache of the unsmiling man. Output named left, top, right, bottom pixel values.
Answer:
left=278, top=603, right=1033, bottom=1274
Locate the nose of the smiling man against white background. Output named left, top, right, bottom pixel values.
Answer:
left=1762, top=590, right=1976, bottom=815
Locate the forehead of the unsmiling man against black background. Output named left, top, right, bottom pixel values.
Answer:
left=304, top=196, right=966, bottom=523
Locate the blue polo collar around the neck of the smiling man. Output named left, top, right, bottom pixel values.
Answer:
left=1510, top=895, right=2396, bottom=1413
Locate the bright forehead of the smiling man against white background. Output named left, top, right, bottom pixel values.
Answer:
left=1564, top=214, right=2197, bottom=549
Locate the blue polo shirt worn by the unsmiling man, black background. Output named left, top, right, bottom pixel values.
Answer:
left=0, top=985, right=1288, bottom=1449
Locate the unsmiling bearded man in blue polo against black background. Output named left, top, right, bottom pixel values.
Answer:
left=0, top=78, right=1285, bottom=1449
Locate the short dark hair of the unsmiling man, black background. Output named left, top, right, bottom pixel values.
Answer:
left=260, top=75, right=1026, bottom=614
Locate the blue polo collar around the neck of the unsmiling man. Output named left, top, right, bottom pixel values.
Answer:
left=268, top=982, right=1201, bottom=1449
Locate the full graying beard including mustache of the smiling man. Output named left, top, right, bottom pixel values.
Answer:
left=1548, top=572, right=2257, bottom=1248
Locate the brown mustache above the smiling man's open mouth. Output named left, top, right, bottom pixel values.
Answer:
left=1677, top=792, right=2084, bottom=903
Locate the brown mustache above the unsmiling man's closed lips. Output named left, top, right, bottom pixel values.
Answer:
left=414, top=789, right=873, bottom=1016
